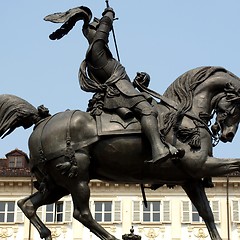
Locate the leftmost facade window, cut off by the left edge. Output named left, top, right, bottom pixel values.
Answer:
left=0, top=201, right=15, bottom=223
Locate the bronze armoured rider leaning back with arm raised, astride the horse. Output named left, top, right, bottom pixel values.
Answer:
left=79, top=7, right=184, bottom=162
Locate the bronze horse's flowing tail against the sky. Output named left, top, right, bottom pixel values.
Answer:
left=0, top=94, right=49, bottom=138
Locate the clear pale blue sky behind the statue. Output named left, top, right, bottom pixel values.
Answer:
left=0, top=0, right=240, bottom=158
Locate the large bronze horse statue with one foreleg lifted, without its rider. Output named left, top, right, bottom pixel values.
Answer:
left=0, top=67, right=240, bottom=240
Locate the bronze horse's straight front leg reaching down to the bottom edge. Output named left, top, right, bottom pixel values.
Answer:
left=182, top=180, right=222, bottom=240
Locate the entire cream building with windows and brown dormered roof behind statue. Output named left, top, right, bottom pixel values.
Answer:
left=0, top=149, right=240, bottom=240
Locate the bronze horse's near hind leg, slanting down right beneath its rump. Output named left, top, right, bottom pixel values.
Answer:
left=68, top=153, right=117, bottom=240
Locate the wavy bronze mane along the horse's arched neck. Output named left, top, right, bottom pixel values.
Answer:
left=163, top=66, right=238, bottom=135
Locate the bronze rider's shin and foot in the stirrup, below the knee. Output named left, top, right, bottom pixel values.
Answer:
left=141, top=114, right=182, bottom=163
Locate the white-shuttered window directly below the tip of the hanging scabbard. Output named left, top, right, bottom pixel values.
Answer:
left=133, top=201, right=171, bottom=223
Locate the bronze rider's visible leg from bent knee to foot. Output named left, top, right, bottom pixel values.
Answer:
left=134, top=101, right=178, bottom=162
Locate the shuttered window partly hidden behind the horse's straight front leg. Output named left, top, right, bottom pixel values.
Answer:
left=182, top=200, right=220, bottom=223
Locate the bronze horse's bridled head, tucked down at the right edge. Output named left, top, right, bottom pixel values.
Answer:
left=212, top=84, right=240, bottom=142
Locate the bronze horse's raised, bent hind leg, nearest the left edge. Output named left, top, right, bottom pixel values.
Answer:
left=18, top=189, right=66, bottom=240
